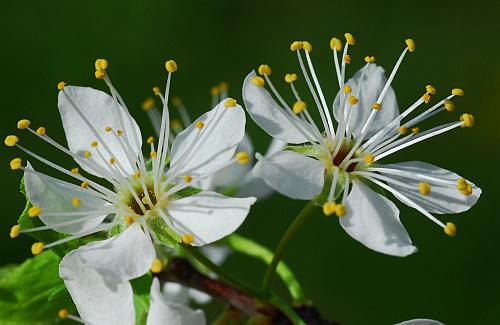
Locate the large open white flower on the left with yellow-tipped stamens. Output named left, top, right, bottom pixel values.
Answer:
left=5, top=59, right=255, bottom=324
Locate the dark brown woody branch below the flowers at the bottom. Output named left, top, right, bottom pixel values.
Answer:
left=156, top=257, right=340, bottom=325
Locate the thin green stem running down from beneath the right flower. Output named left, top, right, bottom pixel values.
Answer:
left=262, top=200, right=315, bottom=293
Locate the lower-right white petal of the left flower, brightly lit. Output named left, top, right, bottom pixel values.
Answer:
left=168, top=191, right=255, bottom=246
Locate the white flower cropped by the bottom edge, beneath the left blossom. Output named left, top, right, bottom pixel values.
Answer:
left=59, top=278, right=207, bottom=325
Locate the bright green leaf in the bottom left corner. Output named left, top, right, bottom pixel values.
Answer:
left=0, top=251, right=74, bottom=325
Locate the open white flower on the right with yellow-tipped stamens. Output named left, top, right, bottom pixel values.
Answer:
left=243, top=37, right=481, bottom=256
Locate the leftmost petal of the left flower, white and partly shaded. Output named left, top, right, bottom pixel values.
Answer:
left=24, top=162, right=109, bottom=234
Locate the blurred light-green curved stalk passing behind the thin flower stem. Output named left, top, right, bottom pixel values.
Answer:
left=223, top=234, right=304, bottom=303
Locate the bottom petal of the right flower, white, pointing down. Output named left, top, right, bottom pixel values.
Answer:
left=340, top=181, right=417, bottom=256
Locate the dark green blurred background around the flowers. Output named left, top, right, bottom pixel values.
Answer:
left=0, top=0, right=500, bottom=325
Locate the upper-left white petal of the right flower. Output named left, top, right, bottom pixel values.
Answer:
left=243, top=71, right=315, bottom=144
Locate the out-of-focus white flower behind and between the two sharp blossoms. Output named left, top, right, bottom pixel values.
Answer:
left=142, top=82, right=285, bottom=200
